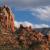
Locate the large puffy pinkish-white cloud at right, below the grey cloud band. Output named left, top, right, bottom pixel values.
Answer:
left=32, top=7, right=50, bottom=21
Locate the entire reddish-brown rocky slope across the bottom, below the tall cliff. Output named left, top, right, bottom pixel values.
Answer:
left=0, top=25, right=50, bottom=50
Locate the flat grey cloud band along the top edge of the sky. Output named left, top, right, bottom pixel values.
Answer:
left=3, top=0, right=50, bottom=8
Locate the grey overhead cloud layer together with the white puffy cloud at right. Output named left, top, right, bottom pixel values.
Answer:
left=3, top=0, right=50, bottom=21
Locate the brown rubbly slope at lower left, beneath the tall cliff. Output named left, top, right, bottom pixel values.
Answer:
left=0, top=33, right=19, bottom=48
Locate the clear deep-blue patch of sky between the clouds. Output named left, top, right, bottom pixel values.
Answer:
left=13, top=9, right=50, bottom=25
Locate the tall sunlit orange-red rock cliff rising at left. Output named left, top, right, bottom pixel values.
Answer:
left=0, top=6, right=14, bottom=32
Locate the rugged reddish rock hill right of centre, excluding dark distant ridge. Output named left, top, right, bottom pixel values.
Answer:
left=15, top=27, right=49, bottom=50
